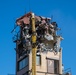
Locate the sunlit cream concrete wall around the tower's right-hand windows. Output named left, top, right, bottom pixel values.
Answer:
left=29, top=52, right=59, bottom=75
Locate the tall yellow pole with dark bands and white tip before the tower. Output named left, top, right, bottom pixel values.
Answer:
left=31, top=13, right=37, bottom=75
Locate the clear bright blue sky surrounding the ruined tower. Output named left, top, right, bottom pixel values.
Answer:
left=0, top=0, right=76, bottom=75
